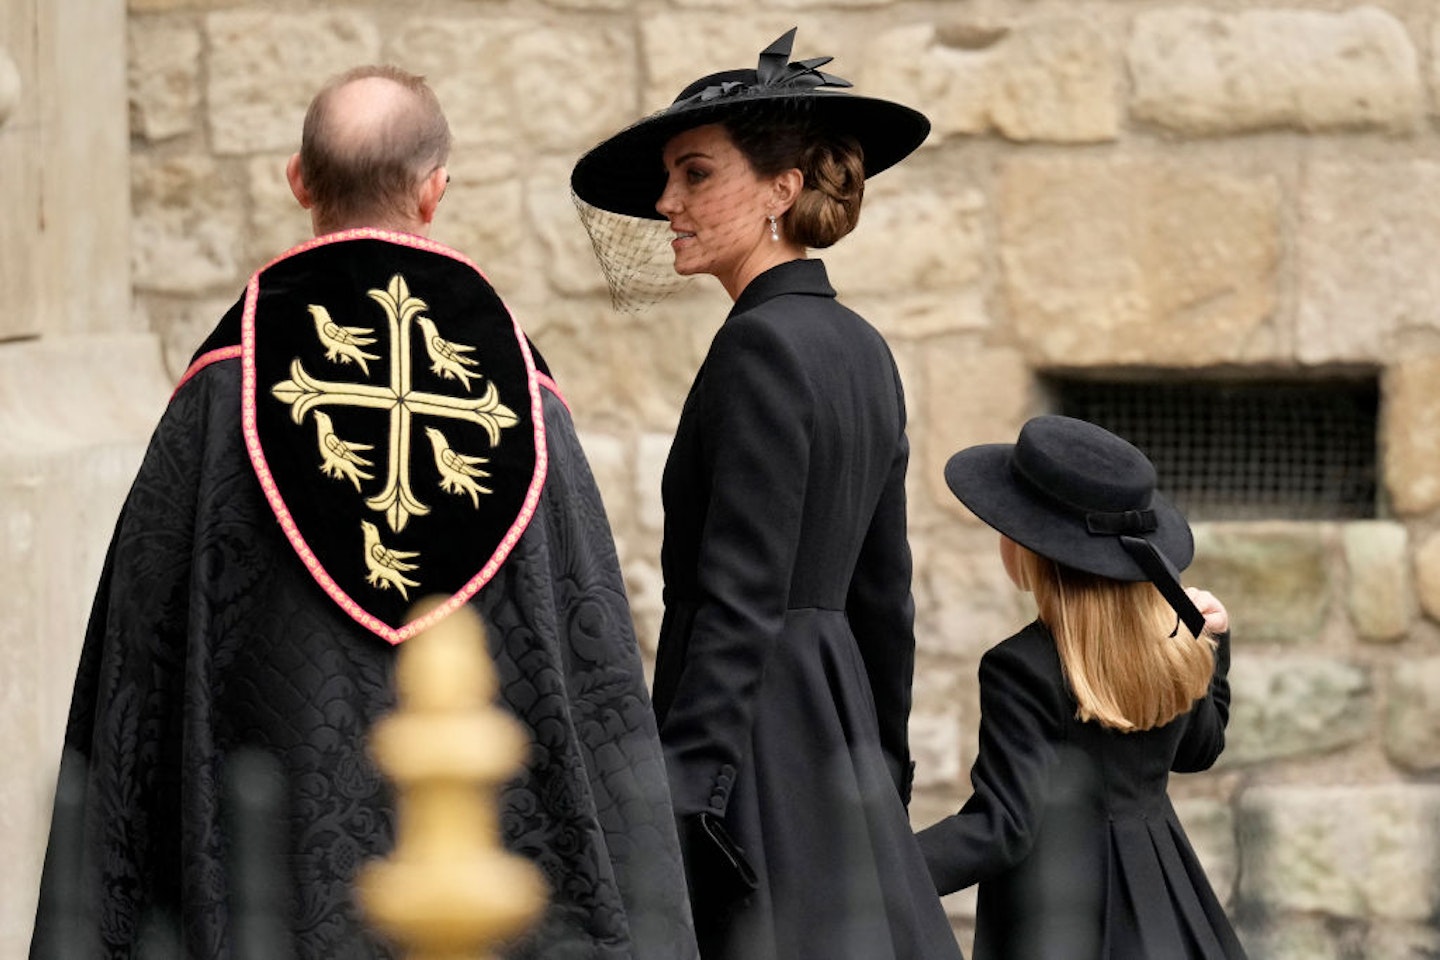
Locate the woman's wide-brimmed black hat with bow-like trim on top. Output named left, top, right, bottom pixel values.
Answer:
left=570, top=29, right=930, bottom=220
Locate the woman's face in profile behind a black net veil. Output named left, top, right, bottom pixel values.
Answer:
left=655, top=124, right=795, bottom=298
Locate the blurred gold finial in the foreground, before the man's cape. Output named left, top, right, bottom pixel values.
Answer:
left=357, top=600, right=546, bottom=960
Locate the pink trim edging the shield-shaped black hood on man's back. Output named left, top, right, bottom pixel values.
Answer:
left=241, top=227, right=550, bottom=645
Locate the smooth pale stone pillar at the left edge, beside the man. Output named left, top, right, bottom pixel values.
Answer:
left=0, top=0, right=168, bottom=960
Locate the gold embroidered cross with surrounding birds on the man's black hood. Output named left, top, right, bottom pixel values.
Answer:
left=271, top=273, right=520, bottom=558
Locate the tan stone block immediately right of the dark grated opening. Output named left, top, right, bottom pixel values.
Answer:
left=1380, top=354, right=1440, bottom=517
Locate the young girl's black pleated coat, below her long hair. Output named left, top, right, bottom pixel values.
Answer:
left=919, top=620, right=1244, bottom=960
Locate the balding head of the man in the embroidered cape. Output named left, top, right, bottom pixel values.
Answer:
left=291, top=66, right=451, bottom=232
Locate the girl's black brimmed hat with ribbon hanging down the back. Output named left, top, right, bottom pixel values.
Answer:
left=945, top=416, right=1205, bottom=636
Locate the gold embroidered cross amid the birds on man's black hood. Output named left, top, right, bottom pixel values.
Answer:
left=271, top=273, right=520, bottom=533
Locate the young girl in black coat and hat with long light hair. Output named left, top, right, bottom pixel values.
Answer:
left=919, top=416, right=1244, bottom=960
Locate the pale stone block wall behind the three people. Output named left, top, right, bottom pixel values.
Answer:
left=92, top=0, right=1440, bottom=960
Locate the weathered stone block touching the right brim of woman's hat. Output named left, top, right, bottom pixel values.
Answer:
left=860, top=16, right=1122, bottom=142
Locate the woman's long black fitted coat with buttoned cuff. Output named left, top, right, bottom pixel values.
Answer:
left=654, top=261, right=959, bottom=960
